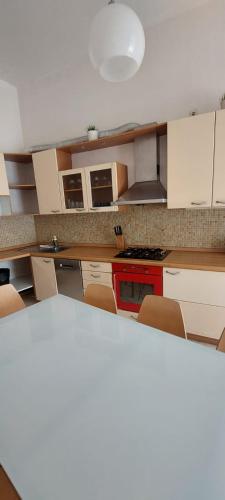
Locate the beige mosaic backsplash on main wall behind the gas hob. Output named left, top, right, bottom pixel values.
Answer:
left=35, top=205, right=225, bottom=248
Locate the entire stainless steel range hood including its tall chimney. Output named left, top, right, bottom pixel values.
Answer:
left=114, top=134, right=167, bottom=205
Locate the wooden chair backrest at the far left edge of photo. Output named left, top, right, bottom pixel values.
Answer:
left=0, top=285, right=25, bottom=318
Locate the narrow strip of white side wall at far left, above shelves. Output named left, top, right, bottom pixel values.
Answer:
left=0, top=80, right=24, bottom=152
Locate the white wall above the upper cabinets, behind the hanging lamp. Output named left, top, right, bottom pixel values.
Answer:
left=20, top=0, right=225, bottom=146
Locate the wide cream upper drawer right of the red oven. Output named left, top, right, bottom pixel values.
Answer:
left=163, top=268, right=225, bottom=307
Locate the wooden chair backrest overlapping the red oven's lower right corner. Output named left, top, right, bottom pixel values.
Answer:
left=138, top=295, right=186, bottom=338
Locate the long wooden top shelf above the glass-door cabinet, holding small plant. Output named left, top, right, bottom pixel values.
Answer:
left=58, top=123, right=167, bottom=154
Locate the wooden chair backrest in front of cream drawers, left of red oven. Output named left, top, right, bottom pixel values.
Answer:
left=84, top=283, right=116, bottom=314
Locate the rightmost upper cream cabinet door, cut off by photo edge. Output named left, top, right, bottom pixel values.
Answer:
left=213, top=110, right=225, bottom=208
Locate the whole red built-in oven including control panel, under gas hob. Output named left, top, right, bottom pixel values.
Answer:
left=112, top=263, right=163, bottom=312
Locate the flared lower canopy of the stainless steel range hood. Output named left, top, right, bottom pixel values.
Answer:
left=115, top=180, right=167, bottom=205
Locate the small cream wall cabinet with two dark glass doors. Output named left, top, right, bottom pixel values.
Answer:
left=59, top=162, right=128, bottom=213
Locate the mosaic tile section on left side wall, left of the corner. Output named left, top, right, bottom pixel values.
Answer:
left=0, top=215, right=36, bottom=248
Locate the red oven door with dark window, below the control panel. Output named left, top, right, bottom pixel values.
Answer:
left=113, top=272, right=163, bottom=312
